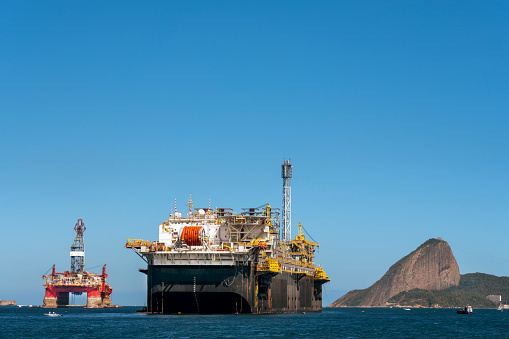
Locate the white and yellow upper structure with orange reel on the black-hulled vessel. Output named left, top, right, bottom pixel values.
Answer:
left=126, top=204, right=279, bottom=265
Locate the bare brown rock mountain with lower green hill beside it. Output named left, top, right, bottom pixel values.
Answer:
left=329, top=238, right=509, bottom=307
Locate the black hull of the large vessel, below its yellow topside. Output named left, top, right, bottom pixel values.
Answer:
left=144, top=265, right=323, bottom=314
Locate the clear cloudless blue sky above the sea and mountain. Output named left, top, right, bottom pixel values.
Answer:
left=0, top=0, right=509, bottom=305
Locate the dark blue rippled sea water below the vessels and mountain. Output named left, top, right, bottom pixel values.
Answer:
left=0, top=307, right=509, bottom=338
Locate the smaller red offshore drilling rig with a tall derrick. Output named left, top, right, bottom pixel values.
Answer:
left=42, top=219, right=113, bottom=308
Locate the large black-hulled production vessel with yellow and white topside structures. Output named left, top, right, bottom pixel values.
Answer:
left=126, top=161, right=330, bottom=314
